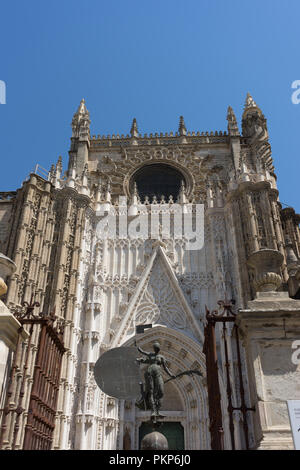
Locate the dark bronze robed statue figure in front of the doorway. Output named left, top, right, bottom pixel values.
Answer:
left=135, top=341, right=176, bottom=417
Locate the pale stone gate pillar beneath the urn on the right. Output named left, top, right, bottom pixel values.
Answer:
left=237, top=292, right=300, bottom=450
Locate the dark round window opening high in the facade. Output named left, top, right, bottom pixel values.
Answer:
left=130, top=163, right=186, bottom=202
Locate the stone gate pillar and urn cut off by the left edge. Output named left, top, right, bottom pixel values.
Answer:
left=0, top=253, right=28, bottom=408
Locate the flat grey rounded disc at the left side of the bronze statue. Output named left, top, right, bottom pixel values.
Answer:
left=94, top=347, right=141, bottom=400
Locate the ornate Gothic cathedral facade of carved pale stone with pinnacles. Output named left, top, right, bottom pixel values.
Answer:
left=0, top=94, right=300, bottom=450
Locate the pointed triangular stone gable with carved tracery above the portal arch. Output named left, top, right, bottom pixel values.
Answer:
left=112, top=245, right=203, bottom=346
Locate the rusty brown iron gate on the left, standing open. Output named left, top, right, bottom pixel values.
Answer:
left=0, top=299, right=65, bottom=450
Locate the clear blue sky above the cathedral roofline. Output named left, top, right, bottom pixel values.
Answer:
left=0, top=0, right=300, bottom=212
